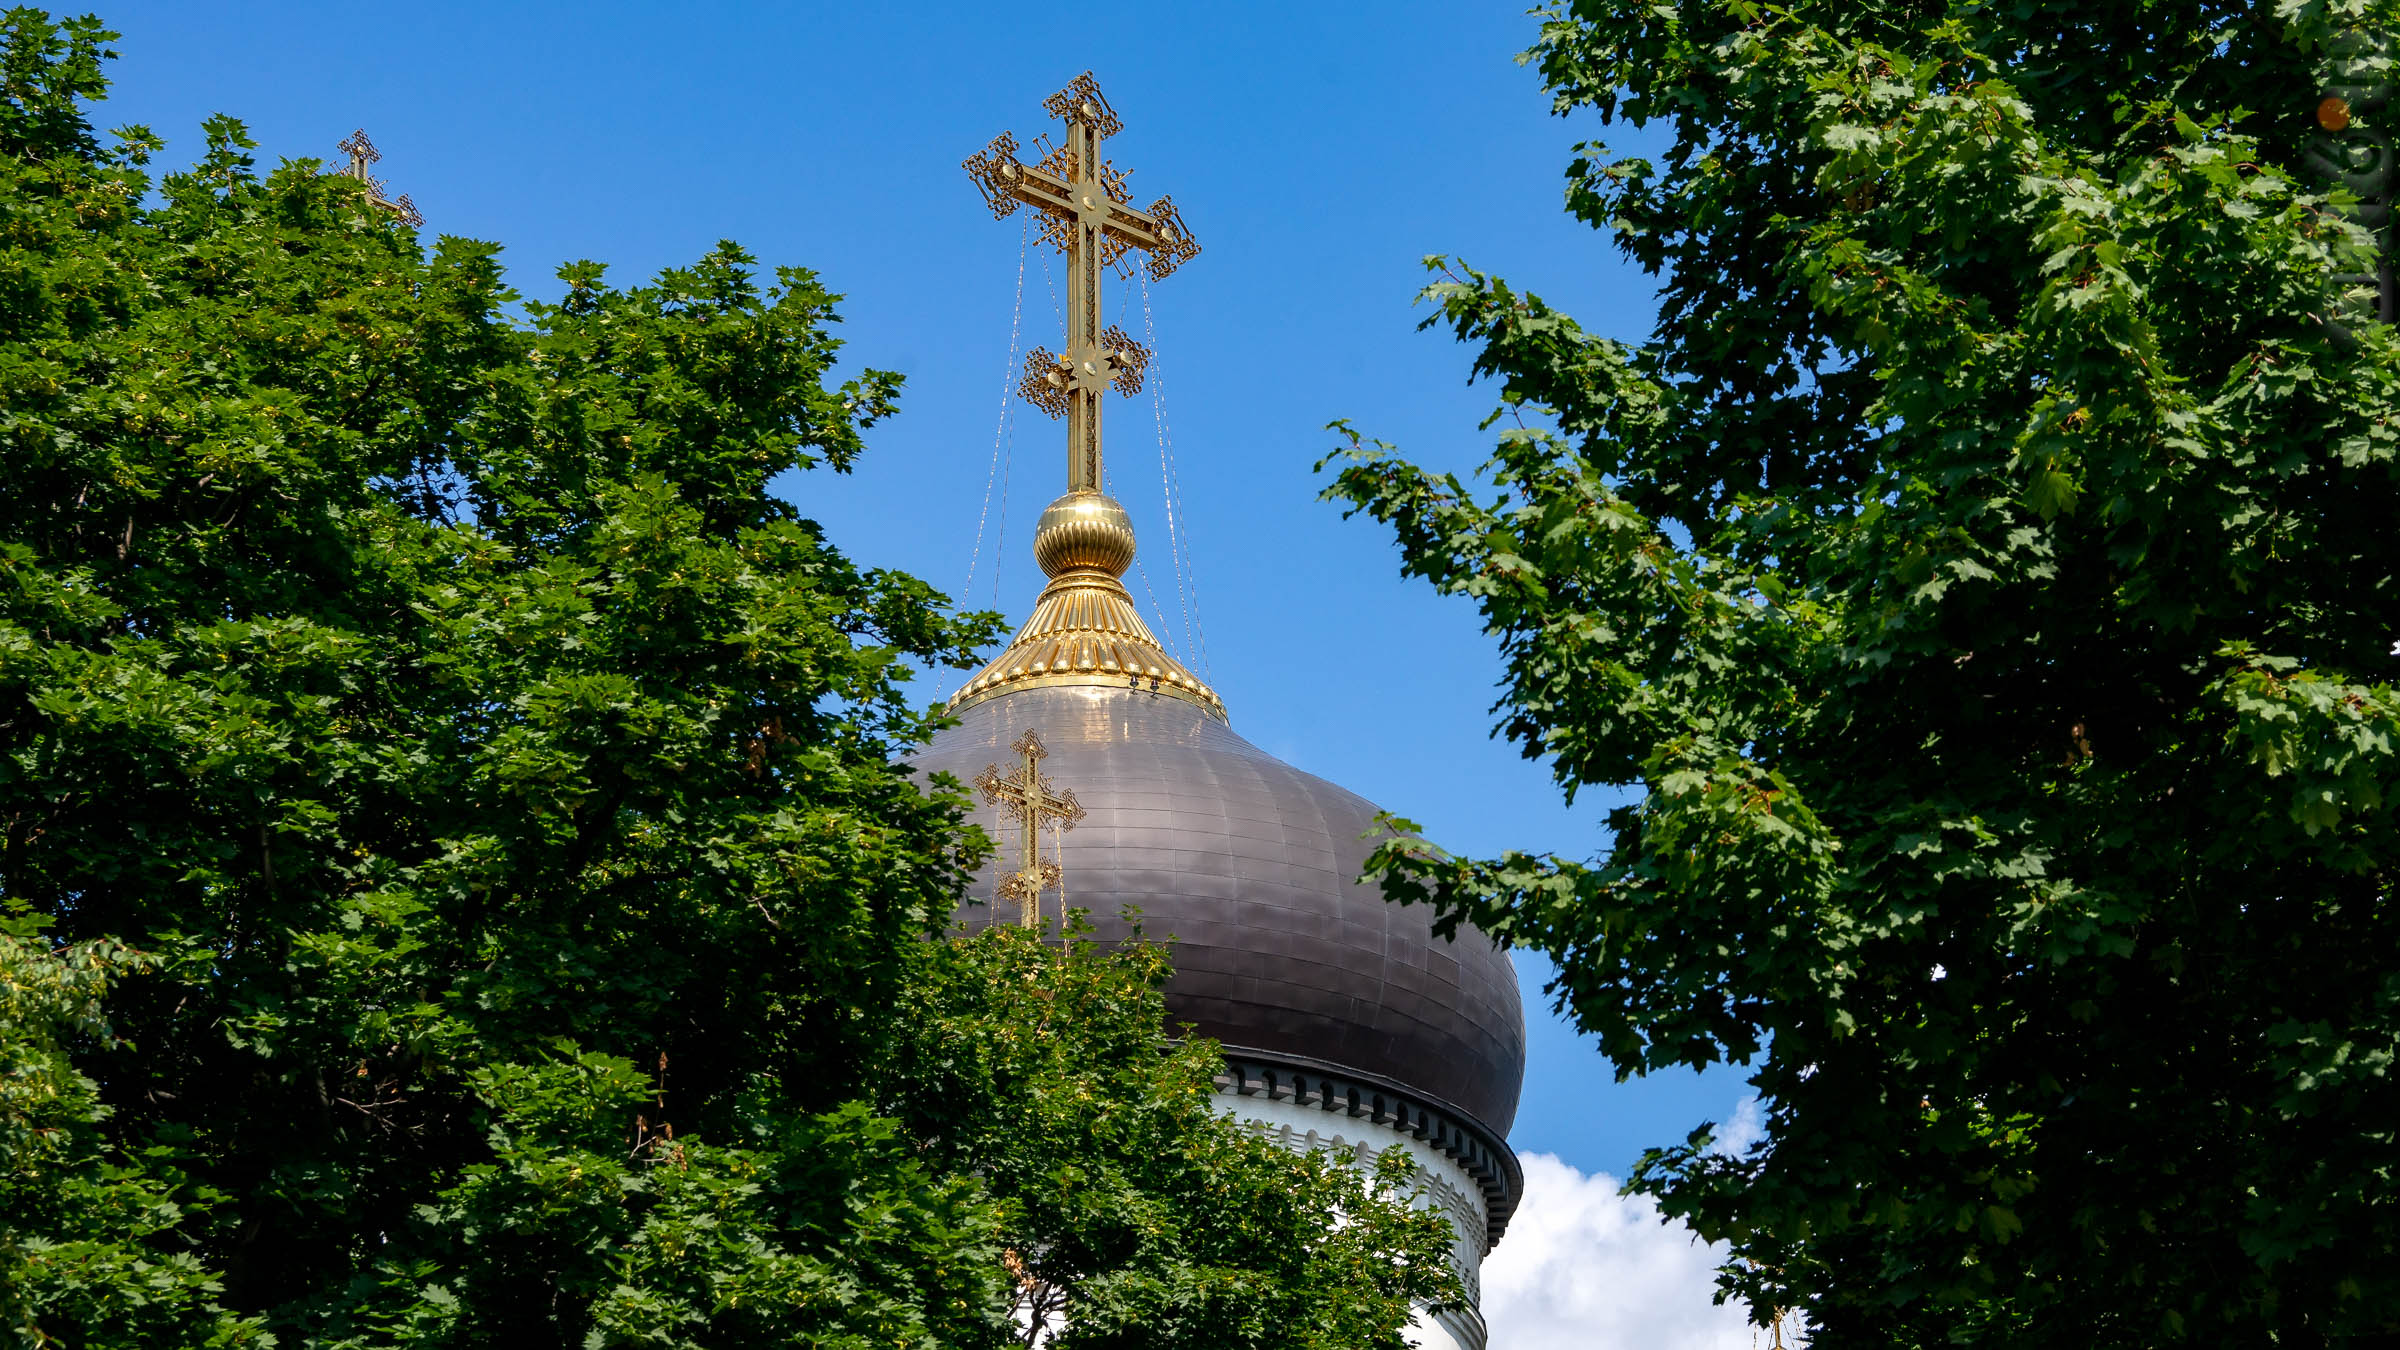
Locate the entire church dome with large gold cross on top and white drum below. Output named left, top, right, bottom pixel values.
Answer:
left=936, top=72, right=1524, bottom=1350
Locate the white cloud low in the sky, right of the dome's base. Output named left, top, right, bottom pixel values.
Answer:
left=1483, top=1143, right=1766, bottom=1350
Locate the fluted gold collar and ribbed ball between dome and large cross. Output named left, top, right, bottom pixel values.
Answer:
left=950, top=492, right=1224, bottom=721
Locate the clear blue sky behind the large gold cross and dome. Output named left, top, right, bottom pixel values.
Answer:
left=98, top=0, right=1745, bottom=1175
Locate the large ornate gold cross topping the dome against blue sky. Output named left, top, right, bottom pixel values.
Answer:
left=965, top=70, right=1200, bottom=492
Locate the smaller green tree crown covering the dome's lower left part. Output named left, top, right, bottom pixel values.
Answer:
left=890, top=927, right=1459, bottom=1350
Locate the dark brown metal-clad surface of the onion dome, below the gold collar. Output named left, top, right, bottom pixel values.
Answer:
left=914, top=682, right=1524, bottom=1143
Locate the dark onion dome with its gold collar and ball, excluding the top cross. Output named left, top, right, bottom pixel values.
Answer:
left=912, top=492, right=1524, bottom=1240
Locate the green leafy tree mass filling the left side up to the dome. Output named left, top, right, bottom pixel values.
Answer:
left=0, top=10, right=1440, bottom=1348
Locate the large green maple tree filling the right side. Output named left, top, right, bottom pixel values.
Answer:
left=1330, top=0, right=2400, bottom=1345
